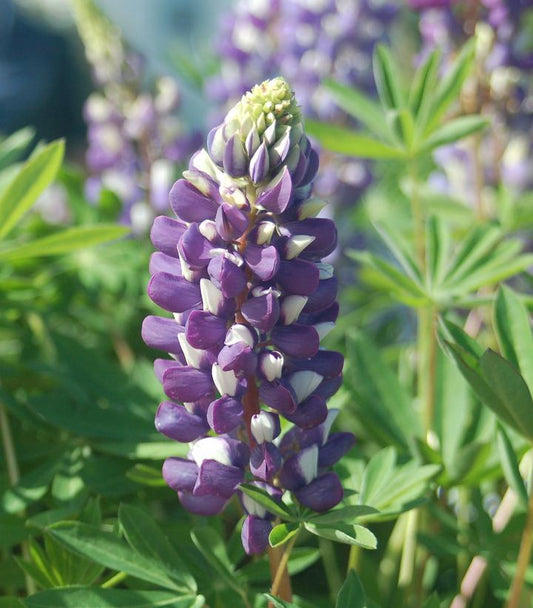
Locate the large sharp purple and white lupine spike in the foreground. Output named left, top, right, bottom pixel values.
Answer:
left=142, top=78, right=353, bottom=553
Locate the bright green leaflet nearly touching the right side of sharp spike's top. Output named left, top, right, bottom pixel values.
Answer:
left=305, top=119, right=405, bottom=159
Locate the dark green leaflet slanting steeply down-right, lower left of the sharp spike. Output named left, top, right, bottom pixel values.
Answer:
left=118, top=504, right=197, bottom=593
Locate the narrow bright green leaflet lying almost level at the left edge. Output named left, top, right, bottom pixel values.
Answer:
left=0, top=224, right=130, bottom=261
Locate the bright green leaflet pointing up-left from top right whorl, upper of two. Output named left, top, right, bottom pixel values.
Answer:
left=322, top=79, right=390, bottom=139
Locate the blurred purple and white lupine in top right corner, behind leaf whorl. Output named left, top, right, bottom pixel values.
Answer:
left=408, top=0, right=533, bottom=206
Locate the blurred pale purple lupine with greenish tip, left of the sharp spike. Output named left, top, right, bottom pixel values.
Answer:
left=74, top=0, right=200, bottom=233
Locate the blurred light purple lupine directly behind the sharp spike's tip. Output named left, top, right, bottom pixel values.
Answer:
left=207, top=0, right=398, bottom=202
